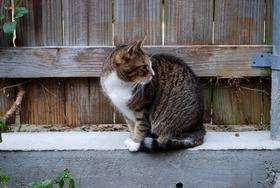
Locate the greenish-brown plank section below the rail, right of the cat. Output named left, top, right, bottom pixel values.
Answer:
left=213, top=78, right=263, bottom=125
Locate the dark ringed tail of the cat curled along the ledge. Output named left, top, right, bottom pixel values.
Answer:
left=140, top=129, right=206, bottom=152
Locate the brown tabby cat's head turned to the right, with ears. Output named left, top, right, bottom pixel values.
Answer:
left=107, top=40, right=155, bottom=83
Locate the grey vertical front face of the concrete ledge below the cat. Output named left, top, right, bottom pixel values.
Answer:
left=0, top=150, right=280, bottom=188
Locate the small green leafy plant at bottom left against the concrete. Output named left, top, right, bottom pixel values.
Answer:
left=30, top=168, right=75, bottom=188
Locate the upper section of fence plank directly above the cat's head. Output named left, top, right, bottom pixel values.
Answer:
left=114, top=0, right=162, bottom=45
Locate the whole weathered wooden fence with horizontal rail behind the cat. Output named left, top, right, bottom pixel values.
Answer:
left=0, top=0, right=273, bottom=126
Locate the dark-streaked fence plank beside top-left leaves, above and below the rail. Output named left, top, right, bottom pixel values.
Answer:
left=17, top=0, right=65, bottom=124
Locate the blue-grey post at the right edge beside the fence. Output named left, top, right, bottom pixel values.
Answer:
left=271, top=0, right=280, bottom=140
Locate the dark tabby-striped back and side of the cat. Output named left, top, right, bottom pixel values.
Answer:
left=148, top=54, right=203, bottom=124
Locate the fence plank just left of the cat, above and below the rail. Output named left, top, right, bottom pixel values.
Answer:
left=63, top=0, right=114, bottom=126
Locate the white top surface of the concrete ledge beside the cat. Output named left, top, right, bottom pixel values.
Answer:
left=0, top=131, right=280, bottom=151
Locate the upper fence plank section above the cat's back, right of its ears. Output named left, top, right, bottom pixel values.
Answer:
left=164, top=0, right=214, bottom=45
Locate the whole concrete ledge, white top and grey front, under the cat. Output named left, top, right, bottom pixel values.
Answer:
left=0, top=131, right=280, bottom=188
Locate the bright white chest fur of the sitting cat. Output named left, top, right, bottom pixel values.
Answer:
left=101, top=72, right=136, bottom=121
